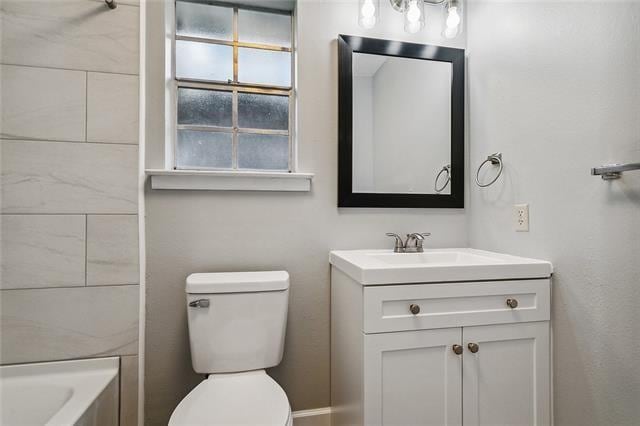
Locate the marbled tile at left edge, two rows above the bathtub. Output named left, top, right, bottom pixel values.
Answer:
left=0, top=215, right=85, bottom=289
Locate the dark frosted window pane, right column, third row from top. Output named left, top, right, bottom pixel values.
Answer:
left=238, top=93, right=289, bottom=130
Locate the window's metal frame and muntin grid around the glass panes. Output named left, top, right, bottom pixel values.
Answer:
left=172, top=0, right=297, bottom=173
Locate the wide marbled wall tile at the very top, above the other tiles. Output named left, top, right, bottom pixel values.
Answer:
left=0, top=0, right=139, bottom=74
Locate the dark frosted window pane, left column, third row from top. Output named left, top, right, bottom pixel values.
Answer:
left=178, top=87, right=233, bottom=127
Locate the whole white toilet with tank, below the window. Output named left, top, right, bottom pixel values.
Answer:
left=169, top=271, right=292, bottom=426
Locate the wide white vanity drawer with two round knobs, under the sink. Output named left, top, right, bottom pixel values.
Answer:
left=363, top=279, right=551, bottom=333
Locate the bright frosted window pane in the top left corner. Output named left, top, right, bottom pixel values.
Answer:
left=176, top=1, right=233, bottom=40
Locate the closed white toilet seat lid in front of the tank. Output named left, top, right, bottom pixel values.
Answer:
left=169, top=370, right=291, bottom=426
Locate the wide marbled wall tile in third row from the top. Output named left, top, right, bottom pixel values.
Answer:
left=0, top=141, right=138, bottom=213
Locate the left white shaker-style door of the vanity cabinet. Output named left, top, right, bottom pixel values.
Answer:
left=363, top=328, right=462, bottom=426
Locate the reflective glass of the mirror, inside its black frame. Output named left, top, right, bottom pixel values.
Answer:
left=352, top=52, right=453, bottom=195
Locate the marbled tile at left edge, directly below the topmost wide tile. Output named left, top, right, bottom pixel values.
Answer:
left=0, top=64, right=86, bottom=141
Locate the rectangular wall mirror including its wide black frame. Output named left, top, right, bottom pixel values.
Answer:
left=338, top=36, right=464, bottom=207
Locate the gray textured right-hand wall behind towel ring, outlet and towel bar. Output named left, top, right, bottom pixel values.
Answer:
left=467, top=1, right=640, bottom=426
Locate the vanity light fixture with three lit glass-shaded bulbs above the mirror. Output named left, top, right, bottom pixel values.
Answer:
left=358, top=0, right=462, bottom=38
